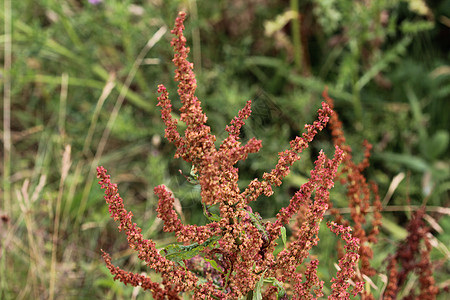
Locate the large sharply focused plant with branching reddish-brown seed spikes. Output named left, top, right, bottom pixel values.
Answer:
left=97, top=12, right=363, bottom=299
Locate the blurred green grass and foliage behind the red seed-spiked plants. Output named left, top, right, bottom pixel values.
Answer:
left=0, top=0, right=450, bottom=299
